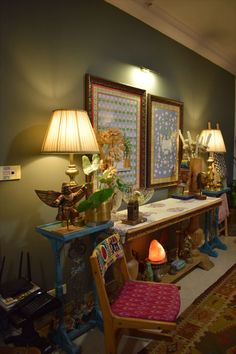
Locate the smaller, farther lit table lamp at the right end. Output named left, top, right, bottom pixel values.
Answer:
left=200, top=122, right=226, bottom=190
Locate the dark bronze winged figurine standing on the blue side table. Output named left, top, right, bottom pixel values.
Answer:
left=35, top=183, right=86, bottom=228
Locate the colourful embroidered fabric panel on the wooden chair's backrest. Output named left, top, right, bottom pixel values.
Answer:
left=94, top=234, right=124, bottom=277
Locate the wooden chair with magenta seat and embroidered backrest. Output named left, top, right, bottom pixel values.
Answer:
left=90, top=234, right=180, bottom=354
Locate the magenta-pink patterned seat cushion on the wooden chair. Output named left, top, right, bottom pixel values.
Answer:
left=111, top=281, right=180, bottom=322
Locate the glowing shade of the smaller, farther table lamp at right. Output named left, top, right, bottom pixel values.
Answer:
left=199, top=129, right=226, bottom=153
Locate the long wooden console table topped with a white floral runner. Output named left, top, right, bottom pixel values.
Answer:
left=113, top=197, right=221, bottom=282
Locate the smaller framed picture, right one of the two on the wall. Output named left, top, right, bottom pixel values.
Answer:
left=147, top=95, right=183, bottom=188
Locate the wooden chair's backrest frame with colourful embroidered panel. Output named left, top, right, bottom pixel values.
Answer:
left=90, top=233, right=129, bottom=317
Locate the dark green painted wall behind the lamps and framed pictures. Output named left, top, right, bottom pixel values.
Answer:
left=0, top=0, right=235, bottom=288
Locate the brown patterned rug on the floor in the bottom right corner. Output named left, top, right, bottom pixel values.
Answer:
left=139, top=264, right=236, bottom=354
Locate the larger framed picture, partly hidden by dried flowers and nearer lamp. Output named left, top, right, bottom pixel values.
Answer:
left=85, top=74, right=146, bottom=188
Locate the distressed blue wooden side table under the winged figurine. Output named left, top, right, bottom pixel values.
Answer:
left=36, top=221, right=113, bottom=354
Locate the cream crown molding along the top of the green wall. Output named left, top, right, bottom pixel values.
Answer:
left=105, top=0, right=236, bottom=76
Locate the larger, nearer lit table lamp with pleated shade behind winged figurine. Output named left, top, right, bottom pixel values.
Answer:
left=41, top=109, right=99, bottom=186
